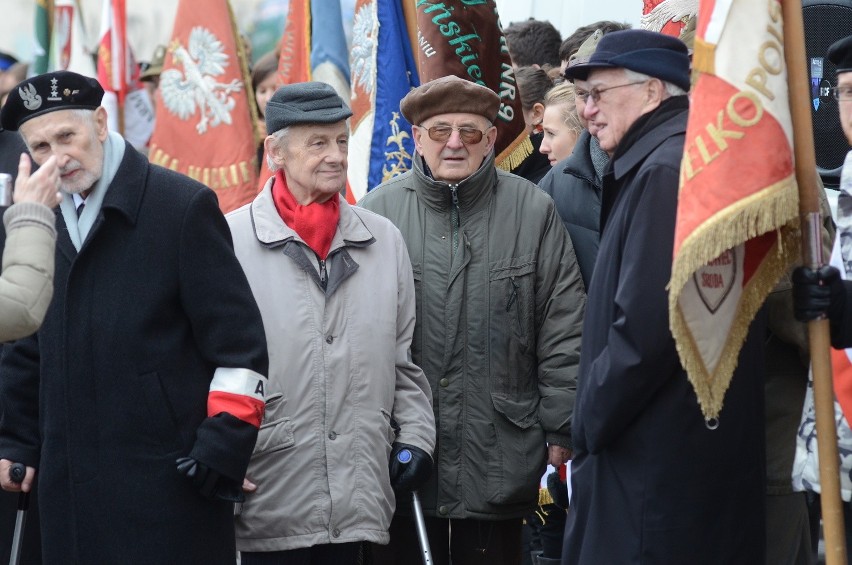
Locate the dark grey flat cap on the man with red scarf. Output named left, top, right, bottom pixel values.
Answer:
left=266, top=82, right=352, bottom=133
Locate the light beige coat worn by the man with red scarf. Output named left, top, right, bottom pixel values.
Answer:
left=228, top=182, right=435, bottom=551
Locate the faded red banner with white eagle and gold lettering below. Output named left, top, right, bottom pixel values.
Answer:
left=148, top=0, right=260, bottom=212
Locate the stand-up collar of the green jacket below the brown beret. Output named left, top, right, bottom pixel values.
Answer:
left=412, top=151, right=497, bottom=213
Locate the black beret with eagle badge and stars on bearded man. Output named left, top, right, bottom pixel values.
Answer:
left=0, top=71, right=104, bottom=131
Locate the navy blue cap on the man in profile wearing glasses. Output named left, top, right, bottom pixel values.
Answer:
left=565, top=29, right=689, bottom=91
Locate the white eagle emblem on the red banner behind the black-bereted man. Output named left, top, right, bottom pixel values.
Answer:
left=160, top=27, right=243, bottom=133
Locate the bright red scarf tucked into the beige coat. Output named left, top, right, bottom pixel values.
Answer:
left=272, top=169, right=340, bottom=260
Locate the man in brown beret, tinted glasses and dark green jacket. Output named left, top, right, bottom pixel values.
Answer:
left=360, top=76, right=586, bottom=565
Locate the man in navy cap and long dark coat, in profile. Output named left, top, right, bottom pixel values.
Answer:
left=562, top=30, right=765, bottom=565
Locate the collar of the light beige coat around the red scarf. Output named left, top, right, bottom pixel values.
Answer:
left=251, top=176, right=375, bottom=254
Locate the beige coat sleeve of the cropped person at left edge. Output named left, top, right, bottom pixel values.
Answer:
left=0, top=202, right=56, bottom=342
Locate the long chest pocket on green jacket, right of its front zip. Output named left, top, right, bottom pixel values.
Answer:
left=488, top=255, right=536, bottom=398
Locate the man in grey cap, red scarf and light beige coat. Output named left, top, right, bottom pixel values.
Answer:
left=227, top=82, right=435, bottom=565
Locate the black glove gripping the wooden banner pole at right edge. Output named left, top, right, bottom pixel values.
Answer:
left=792, top=265, right=846, bottom=322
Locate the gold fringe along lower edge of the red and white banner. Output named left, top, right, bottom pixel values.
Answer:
left=668, top=176, right=801, bottom=419
